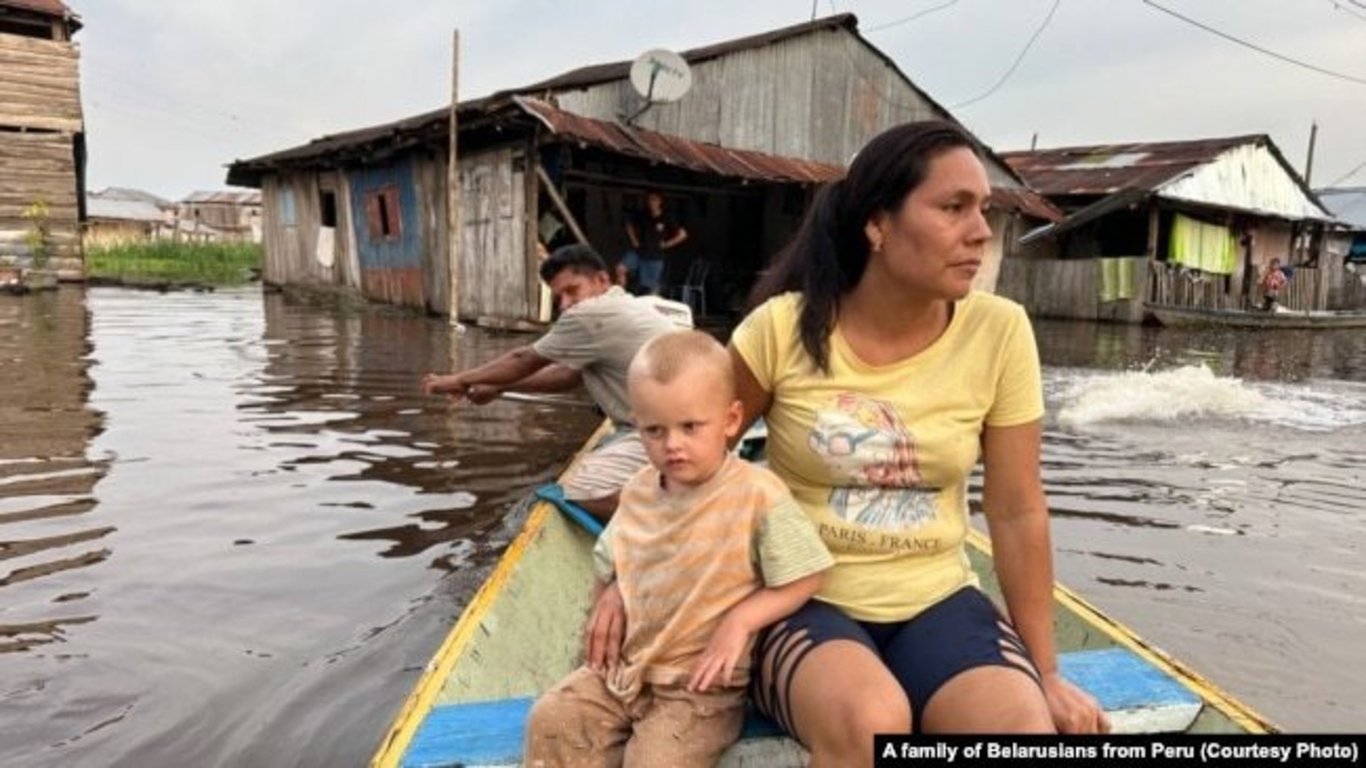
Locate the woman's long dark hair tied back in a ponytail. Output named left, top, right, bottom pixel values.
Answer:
left=750, top=120, right=978, bottom=372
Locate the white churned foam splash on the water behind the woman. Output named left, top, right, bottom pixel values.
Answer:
left=1057, top=365, right=1366, bottom=432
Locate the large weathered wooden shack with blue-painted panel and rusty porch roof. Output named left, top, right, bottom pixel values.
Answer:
left=228, top=14, right=1061, bottom=324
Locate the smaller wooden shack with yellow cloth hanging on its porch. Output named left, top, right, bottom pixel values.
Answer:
left=1000, top=134, right=1343, bottom=323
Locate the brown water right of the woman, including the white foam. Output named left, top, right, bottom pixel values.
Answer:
left=1035, top=323, right=1366, bottom=732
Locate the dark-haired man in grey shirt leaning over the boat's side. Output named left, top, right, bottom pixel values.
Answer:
left=422, top=245, right=678, bottom=519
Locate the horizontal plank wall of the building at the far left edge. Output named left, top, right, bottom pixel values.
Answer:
left=0, top=34, right=85, bottom=277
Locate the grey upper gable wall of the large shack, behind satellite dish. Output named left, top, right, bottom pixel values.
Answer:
left=557, top=29, right=1019, bottom=187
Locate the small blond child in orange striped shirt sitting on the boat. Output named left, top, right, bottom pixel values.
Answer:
left=523, top=331, right=833, bottom=767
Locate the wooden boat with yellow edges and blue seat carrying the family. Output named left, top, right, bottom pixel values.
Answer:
left=370, top=420, right=1276, bottom=768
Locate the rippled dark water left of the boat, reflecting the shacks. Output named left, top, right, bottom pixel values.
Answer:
left=0, top=284, right=594, bottom=767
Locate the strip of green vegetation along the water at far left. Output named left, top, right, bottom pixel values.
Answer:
left=86, top=241, right=262, bottom=286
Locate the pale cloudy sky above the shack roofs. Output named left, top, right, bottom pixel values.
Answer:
left=79, top=0, right=1366, bottom=198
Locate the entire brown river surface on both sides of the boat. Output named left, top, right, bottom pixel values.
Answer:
left=0, top=288, right=1366, bottom=767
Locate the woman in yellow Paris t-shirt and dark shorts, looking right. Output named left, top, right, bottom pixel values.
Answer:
left=587, top=122, right=1108, bottom=765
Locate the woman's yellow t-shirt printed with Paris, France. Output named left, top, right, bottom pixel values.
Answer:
left=731, top=292, right=1044, bottom=622
